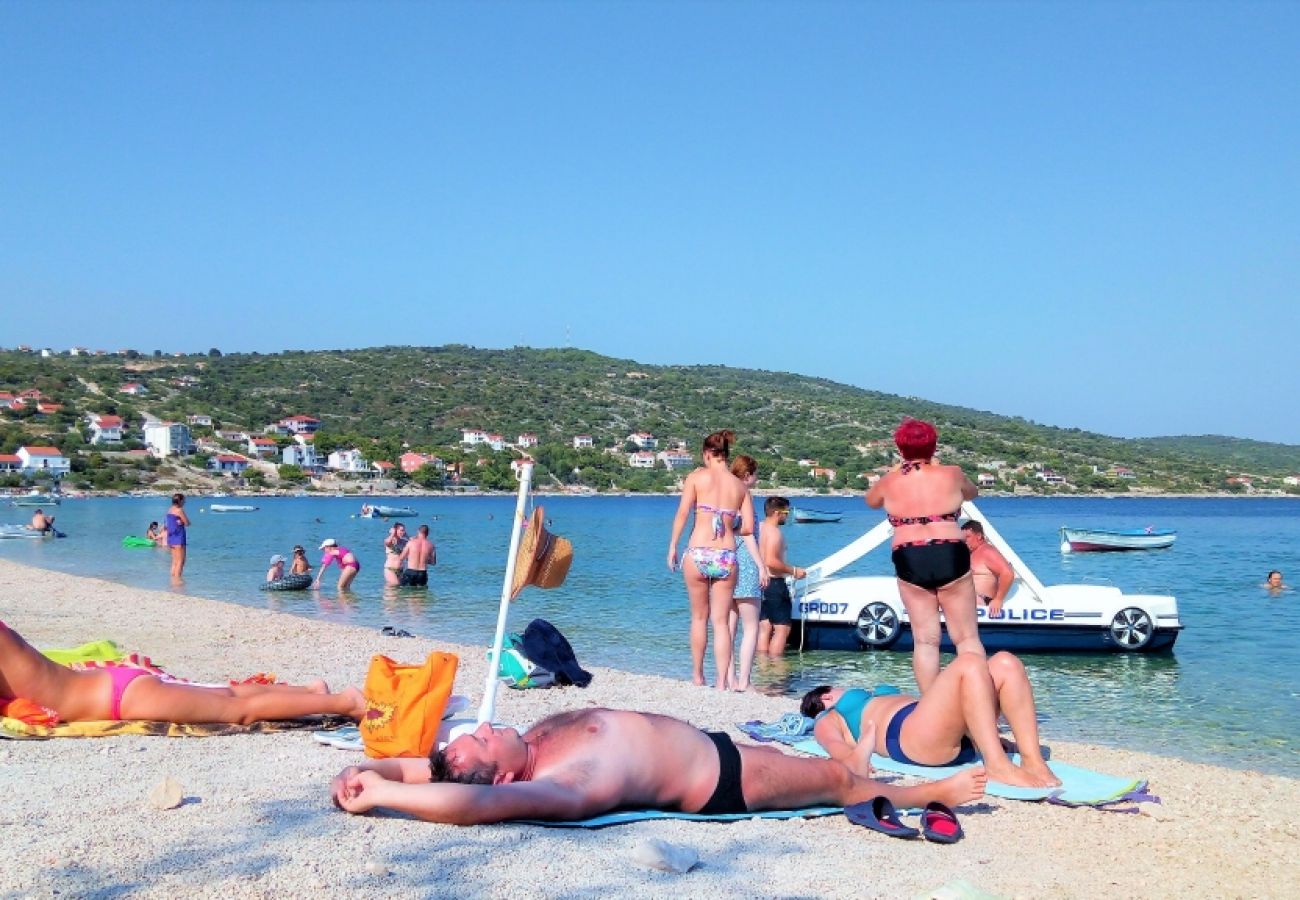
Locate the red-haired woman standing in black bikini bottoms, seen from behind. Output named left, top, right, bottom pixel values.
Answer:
left=867, top=419, right=984, bottom=693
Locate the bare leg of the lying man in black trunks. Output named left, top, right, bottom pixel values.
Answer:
left=737, top=744, right=988, bottom=812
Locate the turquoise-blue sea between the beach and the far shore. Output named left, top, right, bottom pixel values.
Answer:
left=0, top=497, right=1300, bottom=776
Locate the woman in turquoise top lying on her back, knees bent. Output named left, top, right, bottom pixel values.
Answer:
left=801, top=653, right=1061, bottom=787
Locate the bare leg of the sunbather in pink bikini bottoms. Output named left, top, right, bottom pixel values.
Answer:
left=121, top=676, right=365, bottom=724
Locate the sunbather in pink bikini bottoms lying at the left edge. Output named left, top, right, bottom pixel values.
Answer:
left=0, top=622, right=365, bottom=724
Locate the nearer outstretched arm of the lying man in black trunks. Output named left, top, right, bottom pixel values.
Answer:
left=338, top=771, right=618, bottom=825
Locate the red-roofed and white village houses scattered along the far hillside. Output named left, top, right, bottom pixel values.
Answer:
left=0, top=346, right=1300, bottom=494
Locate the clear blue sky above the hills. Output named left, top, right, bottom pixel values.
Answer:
left=0, top=0, right=1300, bottom=443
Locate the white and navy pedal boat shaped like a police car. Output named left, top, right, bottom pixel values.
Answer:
left=794, top=502, right=1183, bottom=653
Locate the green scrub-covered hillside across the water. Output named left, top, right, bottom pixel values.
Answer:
left=0, top=345, right=1300, bottom=493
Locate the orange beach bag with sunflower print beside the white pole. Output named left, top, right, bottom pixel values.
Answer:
left=360, top=650, right=460, bottom=760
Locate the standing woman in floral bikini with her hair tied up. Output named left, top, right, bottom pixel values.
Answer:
left=668, top=430, right=754, bottom=691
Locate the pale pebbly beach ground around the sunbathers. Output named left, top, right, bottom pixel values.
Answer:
left=0, top=561, right=1300, bottom=899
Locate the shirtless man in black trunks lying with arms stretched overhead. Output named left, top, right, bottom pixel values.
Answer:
left=330, top=709, right=988, bottom=825
